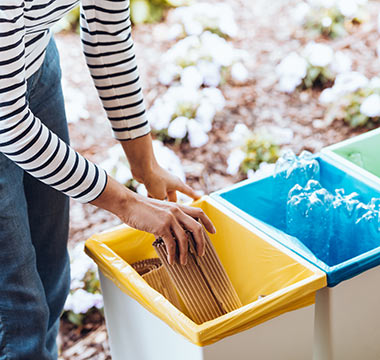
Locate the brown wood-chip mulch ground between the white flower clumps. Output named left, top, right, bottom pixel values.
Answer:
left=56, top=0, right=380, bottom=360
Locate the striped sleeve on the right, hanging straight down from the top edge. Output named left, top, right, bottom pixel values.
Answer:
left=80, top=0, right=150, bottom=140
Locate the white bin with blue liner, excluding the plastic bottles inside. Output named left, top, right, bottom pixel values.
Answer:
left=211, top=154, right=380, bottom=360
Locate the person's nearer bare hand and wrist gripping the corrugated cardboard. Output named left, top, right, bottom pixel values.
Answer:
left=92, top=177, right=215, bottom=265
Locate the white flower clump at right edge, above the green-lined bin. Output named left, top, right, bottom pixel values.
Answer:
left=319, top=72, right=380, bottom=127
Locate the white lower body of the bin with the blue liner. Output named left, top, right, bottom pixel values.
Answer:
left=314, top=266, right=380, bottom=360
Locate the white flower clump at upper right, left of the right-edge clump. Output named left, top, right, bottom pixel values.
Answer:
left=276, top=41, right=351, bottom=93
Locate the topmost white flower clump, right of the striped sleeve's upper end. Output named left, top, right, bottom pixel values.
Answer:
left=170, top=3, right=238, bottom=38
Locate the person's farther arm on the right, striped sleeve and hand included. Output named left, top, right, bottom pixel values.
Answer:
left=81, top=0, right=202, bottom=201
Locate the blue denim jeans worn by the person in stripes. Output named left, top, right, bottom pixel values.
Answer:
left=0, top=40, right=70, bottom=360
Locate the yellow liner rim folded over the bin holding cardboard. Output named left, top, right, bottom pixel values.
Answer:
left=85, top=196, right=327, bottom=346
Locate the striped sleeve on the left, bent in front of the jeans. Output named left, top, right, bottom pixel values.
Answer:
left=0, top=0, right=107, bottom=203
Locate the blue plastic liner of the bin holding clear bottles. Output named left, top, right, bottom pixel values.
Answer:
left=211, top=155, right=380, bottom=287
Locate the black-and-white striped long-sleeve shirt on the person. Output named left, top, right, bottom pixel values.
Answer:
left=0, top=0, right=149, bottom=202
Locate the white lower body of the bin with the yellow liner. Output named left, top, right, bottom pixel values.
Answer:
left=100, top=272, right=314, bottom=360
